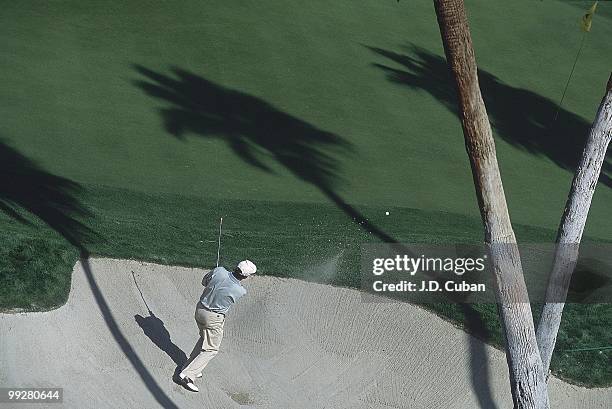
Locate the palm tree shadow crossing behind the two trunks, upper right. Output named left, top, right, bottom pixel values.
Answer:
left=367, top=45, right=612, bottom=187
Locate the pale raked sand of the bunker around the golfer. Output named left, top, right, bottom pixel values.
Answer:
left=0, top=259, right=612, bottom=409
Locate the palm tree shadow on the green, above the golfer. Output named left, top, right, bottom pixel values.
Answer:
left=134, top=65, right=396, bottom=242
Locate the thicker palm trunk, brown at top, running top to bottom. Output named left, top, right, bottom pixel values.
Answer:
left=434, top=0, right=549, bottom=409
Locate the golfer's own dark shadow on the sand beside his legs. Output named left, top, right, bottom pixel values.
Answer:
left=134, top=310, right=202, bottom=378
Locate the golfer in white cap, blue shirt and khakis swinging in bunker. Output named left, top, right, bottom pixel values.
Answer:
left=179, top=260, right=257, bottom=392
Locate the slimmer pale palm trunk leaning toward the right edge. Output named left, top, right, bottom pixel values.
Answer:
left=537, top=75, right=612, bottom=373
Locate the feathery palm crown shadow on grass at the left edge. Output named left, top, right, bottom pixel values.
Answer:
left=0, top=140, right=98, bottom=250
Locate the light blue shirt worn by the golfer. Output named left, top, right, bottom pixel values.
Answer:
left=200, top=267, right=246, bottom=314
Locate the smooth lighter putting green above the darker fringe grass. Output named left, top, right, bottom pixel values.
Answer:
left=0, top=0, right=612, bottom=238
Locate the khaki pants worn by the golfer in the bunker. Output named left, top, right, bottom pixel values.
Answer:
left=182, top=303, right=225, bottom=380
